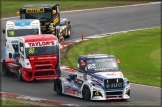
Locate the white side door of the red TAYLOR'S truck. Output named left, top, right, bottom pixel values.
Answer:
left=19, top=42, right=25, bottom=67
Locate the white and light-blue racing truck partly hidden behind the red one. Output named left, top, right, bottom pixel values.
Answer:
left=2, top=19, right=41, bottom=58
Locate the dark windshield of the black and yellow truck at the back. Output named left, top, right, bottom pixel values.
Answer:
left=25, top=12, right=51, bottom=21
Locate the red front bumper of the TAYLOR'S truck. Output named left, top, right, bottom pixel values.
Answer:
left=20, top=68, right=58, bottom=81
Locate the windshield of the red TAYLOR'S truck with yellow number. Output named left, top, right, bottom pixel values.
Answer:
left=25, top=45, right=58, bottom=57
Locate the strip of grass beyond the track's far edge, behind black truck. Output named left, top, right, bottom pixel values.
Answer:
left=1, top=0, right=160, bottom=17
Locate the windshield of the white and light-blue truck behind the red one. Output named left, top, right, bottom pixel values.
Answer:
left=7, top=29, right=39, bottom=37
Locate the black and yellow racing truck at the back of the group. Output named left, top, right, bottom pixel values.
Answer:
left=17, top=4, right=71, bottom=40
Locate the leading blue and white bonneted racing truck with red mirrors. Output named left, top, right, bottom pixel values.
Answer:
left=53, top=54, right=130, bottom=100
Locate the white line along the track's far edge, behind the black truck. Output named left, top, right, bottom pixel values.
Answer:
left=0, top=2, right=161, bottom=20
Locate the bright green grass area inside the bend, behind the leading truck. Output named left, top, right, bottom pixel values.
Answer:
left=61, top=28, right=161, bottom=87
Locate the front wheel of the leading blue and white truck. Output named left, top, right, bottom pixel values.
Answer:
left=82, top=85, right=91, bottom=101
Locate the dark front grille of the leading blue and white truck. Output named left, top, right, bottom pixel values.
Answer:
left=104, top=78, right=123, bottom=89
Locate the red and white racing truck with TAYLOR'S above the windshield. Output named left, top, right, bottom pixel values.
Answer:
left=2, top=34, right=61, bottom=82
